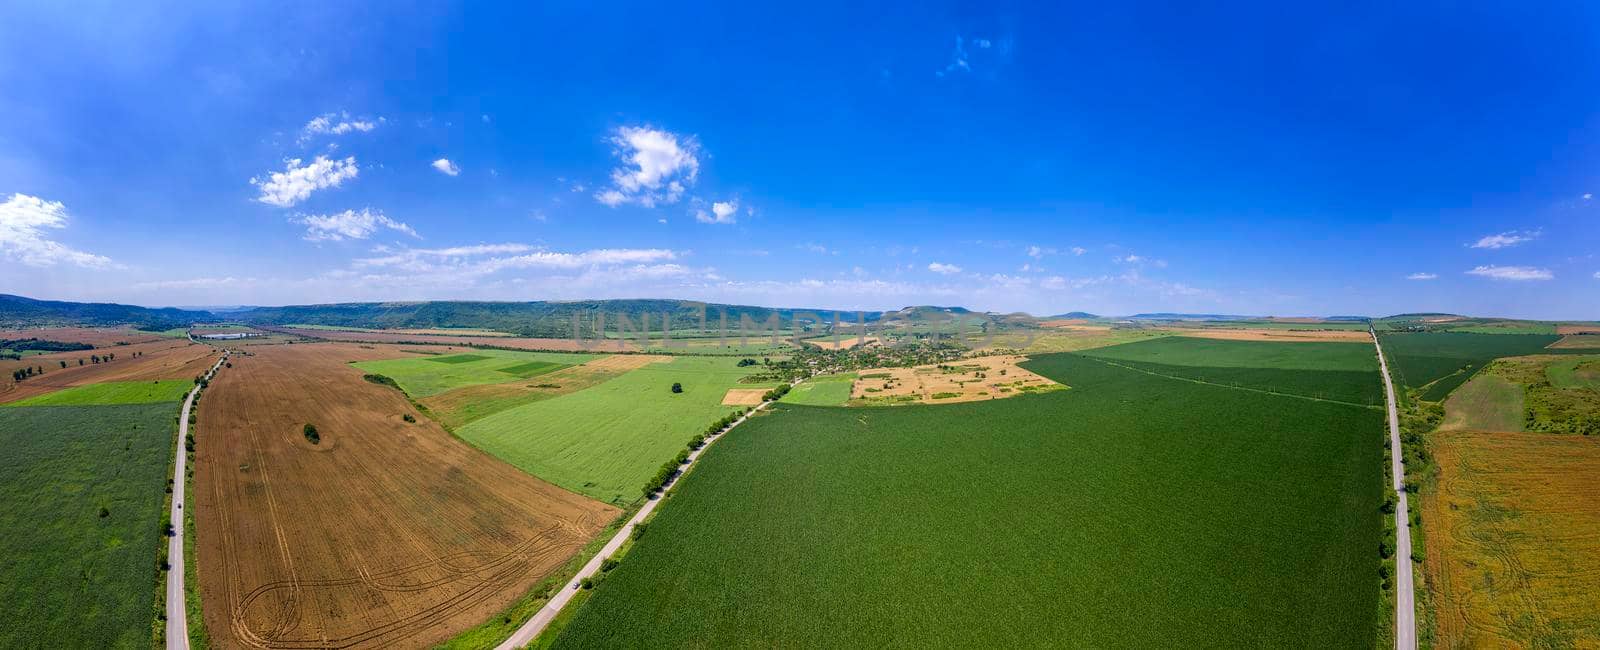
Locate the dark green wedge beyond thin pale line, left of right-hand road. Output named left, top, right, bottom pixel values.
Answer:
left=1083, top=336, right=1384, bottom=405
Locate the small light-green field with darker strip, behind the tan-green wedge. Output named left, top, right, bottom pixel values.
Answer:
left=355, top=349, right=602, bottom=397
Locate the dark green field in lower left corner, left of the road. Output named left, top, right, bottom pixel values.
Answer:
left=0, top=402, right=178, bottom=648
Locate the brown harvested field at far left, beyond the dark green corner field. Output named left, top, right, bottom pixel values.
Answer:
left=0, top=339, right=219, bottom=403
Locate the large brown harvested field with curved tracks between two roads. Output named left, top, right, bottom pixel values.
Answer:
left=192, top=343, right=618, bottom=648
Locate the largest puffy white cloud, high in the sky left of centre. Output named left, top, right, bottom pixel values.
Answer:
left=595, top=126, right=699, bottom=208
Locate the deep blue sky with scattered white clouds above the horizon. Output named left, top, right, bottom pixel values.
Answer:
left=0, top=3, right=1600, bottom=319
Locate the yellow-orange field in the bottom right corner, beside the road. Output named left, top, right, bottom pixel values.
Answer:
left=1422, top=432, right=1600, bottom=648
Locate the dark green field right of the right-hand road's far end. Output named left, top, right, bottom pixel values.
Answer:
left=1379, top=331, right=1562, bottom=402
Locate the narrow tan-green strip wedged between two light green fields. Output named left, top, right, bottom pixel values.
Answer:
left=419, top=349, right=672, bottom=431
